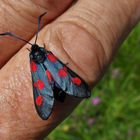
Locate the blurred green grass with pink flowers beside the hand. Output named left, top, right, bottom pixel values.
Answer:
left=47, top=24, right=140, bottom=140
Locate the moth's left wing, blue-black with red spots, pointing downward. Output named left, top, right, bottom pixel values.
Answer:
left=30, top=60, right=54, bottom=120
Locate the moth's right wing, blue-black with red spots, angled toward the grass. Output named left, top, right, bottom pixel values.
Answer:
left=44, top=52, right=91, bottom=98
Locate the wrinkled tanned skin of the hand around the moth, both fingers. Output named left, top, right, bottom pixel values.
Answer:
left=0, top=0, right=140, bottom=140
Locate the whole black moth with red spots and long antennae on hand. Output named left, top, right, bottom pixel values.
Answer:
left=0, top=12, right=91, bottom=120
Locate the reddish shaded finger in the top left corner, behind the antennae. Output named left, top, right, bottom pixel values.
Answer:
left=0, top=0, right=72, bottom=68
